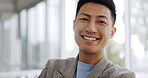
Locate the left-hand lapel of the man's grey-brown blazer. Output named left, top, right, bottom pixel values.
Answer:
left=53, top=58, right=78, bottom=78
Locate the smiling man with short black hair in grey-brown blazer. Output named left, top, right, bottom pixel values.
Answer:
left=39, top=0, right=135, bottom=78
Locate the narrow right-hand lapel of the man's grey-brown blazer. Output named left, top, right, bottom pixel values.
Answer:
left=87, top=56, right=108, bottom=78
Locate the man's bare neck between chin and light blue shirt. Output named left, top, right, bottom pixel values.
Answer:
left=79, top=52, right=103, bottom=65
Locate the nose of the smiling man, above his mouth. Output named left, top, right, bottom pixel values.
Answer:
left=85, top=21, right=97, bottom=33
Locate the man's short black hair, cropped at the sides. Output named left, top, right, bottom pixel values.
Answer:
left=76, top=0, right=116, bottom=25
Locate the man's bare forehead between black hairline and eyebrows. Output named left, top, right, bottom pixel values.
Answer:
left=78, top=2, right=111, bottom=19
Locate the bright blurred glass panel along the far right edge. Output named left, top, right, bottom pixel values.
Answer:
left=130, top=0, right=148, bottom=78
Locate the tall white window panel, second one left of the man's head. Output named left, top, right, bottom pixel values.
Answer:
left=46, top=0, right=62, bottom=60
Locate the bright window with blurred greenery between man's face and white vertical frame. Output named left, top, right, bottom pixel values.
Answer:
left=105, top=0, right=125, bottom=67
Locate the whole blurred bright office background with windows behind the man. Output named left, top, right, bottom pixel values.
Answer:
left=0, top=0, right=148, bottom=78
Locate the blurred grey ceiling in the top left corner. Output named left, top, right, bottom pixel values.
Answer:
left=0, top=0, right=43, bottom=21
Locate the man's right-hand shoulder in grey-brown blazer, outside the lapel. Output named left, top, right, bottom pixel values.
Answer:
left=102, top=61, right=135, bottom=78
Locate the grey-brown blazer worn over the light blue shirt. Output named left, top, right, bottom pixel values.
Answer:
left=38, top=56, right=135, bottom=78
